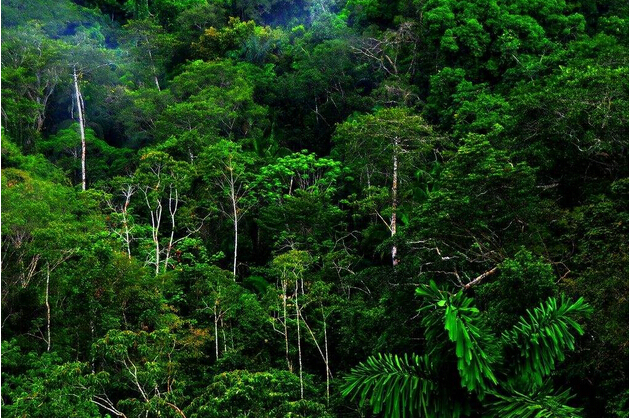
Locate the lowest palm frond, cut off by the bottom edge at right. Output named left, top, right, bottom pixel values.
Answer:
left=486, top=381, right=582, bottom=418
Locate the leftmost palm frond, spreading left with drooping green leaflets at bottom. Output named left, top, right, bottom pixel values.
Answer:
left=343, top=354, right=459, bottom=418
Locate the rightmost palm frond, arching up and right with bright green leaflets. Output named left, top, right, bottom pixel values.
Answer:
left=502, top=296, right=592, bottom=385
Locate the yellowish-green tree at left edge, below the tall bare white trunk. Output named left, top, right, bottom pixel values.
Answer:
left=2, top=143, right=103, bottom=351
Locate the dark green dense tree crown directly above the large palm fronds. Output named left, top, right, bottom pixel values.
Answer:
left=405, top=134, right=544, bottom=287
